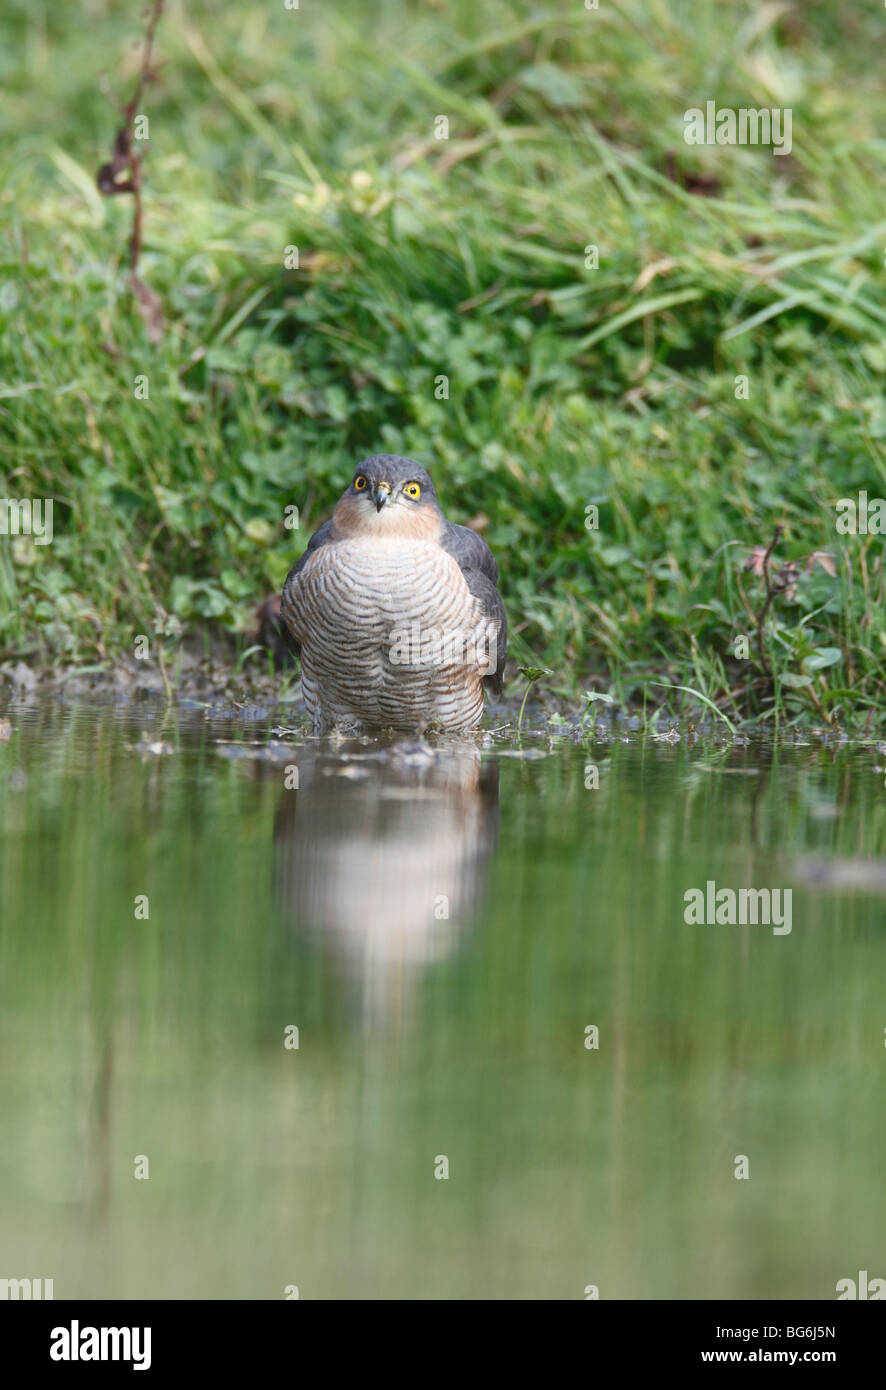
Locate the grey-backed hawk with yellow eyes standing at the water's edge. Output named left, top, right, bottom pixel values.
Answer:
left=280, top=453, right=508, bottom=734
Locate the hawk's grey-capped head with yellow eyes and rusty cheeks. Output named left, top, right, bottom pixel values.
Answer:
left=332, top=453, right=442, bottom=541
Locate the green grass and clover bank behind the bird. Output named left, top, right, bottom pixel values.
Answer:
left=0, top=0, right=886, bottom=727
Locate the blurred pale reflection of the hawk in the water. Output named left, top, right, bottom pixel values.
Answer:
left=274, top=738, right=498, bottom=1031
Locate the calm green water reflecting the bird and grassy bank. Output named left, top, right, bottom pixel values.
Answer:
left=0, top=699, right=886, bottom=1298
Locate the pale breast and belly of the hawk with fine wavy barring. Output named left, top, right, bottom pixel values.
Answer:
left=292, top=538, right=487, bottom=728
